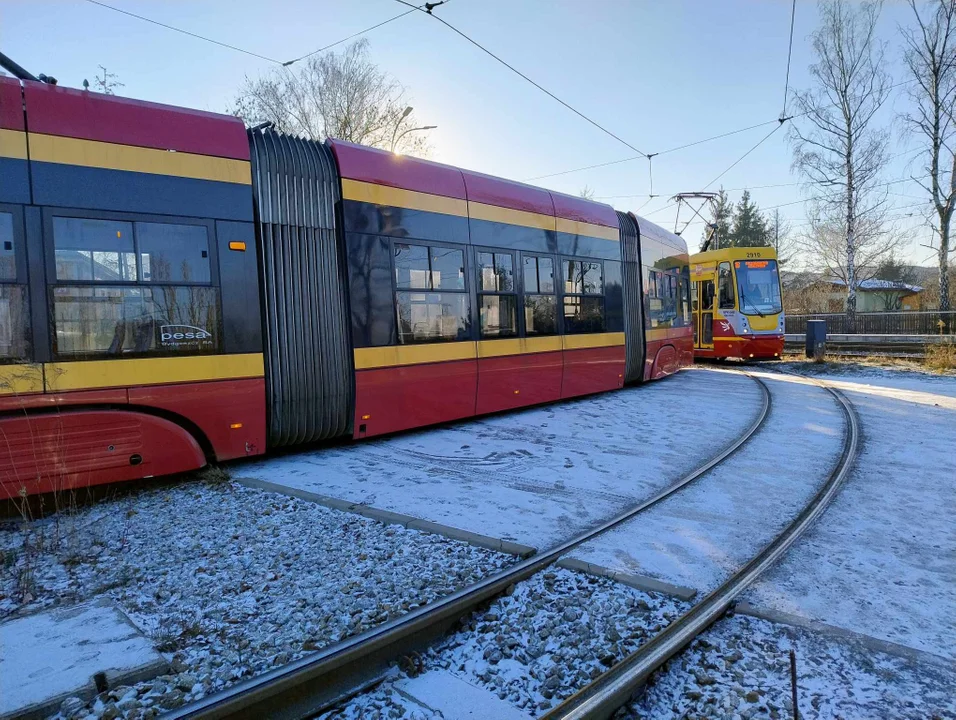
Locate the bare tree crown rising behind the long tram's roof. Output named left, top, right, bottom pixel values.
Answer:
left=233, top=40, right=428, bottom=156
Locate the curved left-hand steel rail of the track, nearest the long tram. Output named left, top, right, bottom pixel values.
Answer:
left=162, top=373, right=772, bottom=720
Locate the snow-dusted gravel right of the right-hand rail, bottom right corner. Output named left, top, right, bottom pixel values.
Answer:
left=622, top=615, right=956, bottom=720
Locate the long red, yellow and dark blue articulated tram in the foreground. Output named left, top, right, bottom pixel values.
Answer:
left=0, top=77, right=693, bottom=497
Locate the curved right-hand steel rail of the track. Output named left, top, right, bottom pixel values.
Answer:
left=541, top=376, right=860, bottom=720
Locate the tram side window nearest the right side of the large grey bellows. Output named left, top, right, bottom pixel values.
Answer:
left=394, top=243, right=471, bottom=345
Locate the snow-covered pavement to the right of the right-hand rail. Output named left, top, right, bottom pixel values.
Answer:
left=746, top=363, right=956, bottom=659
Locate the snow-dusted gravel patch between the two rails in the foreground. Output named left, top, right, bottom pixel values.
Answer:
left=323, top=568, right=688, bottom=719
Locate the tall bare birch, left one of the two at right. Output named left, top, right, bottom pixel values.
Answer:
left=791, top=0, right=899, bottom=328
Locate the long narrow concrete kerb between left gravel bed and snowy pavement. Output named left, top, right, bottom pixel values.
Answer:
left=234, top=478, right=538, bottom=558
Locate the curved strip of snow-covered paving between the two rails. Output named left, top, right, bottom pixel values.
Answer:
left=572, top=373, right=844, bottom=592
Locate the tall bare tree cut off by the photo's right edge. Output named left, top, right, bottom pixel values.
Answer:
left=900, top=0, right=956, bottom=320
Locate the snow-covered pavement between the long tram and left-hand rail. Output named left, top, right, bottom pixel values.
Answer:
left=236, top=370, right=760, bottom=548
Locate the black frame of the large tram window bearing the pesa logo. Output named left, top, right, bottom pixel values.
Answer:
left=42, top=207, right=225, bottom=362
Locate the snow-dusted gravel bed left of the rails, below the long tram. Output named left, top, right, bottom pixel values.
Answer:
left=0, top=482, right=513, bottom=717
